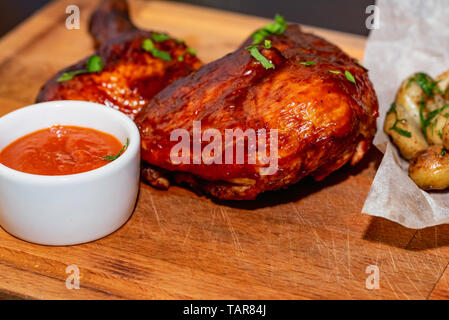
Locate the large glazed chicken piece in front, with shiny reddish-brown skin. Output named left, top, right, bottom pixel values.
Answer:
left=136, top=25, right=378, bottom=200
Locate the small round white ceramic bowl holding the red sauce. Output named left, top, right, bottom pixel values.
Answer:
left=0, top=101, right=140, bottom=245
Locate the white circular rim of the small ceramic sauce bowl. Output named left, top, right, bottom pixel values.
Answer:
left=0, top=100, right=140, bottom=185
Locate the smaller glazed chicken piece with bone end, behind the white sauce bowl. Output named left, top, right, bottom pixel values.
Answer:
left=37, top=0, right=201, bottom=118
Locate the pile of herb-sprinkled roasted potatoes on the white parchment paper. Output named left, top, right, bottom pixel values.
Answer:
left=384, top=71, right=449, bottom=190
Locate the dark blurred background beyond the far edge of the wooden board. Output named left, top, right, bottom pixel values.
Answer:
left=0, top=0, right=374, bottom=36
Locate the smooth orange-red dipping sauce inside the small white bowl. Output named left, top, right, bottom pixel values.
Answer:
left=0, top=125, right=123, bottom=176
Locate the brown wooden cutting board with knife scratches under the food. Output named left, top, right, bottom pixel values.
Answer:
left=0, top=0, right=449, bottom=299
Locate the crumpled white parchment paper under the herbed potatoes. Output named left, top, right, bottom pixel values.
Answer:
left=362, top=0, right=449, bottom=229
